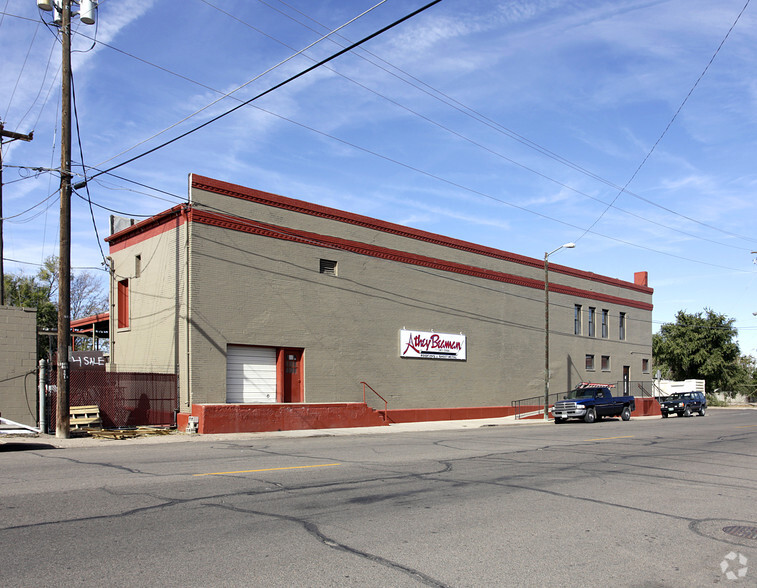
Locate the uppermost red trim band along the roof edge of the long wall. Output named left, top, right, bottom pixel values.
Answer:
left=191, top=174, right=654, bottom=294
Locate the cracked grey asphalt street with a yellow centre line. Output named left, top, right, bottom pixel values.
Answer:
left=0, top=410, right=757, bottom=587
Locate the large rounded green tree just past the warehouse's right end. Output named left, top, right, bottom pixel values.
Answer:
left=652, top=308, right=747, bottom=392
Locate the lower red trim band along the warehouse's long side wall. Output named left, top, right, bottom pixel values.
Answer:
left=192, top=210, right=653, bottom=311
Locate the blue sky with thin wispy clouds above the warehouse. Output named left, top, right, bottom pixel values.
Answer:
left=0, top=0, right=757, bottom=356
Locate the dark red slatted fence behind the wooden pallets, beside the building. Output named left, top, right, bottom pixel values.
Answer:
left=46, top=370, right=179, bottom=433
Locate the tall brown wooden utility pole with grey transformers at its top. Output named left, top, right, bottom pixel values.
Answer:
left=37, top=0, right=97, bottom=439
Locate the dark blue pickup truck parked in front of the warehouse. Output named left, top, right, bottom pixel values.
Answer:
left=552, top=384, right=636, bottom=424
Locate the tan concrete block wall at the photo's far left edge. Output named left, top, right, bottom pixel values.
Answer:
left=0, top=306, right=37, bottom=426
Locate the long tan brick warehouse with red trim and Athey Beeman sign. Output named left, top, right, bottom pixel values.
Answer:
left=107, top=175, right=653, bottom=428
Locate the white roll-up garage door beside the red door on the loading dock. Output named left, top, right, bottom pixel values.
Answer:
left=226, top=345, right=276, bottom=403
